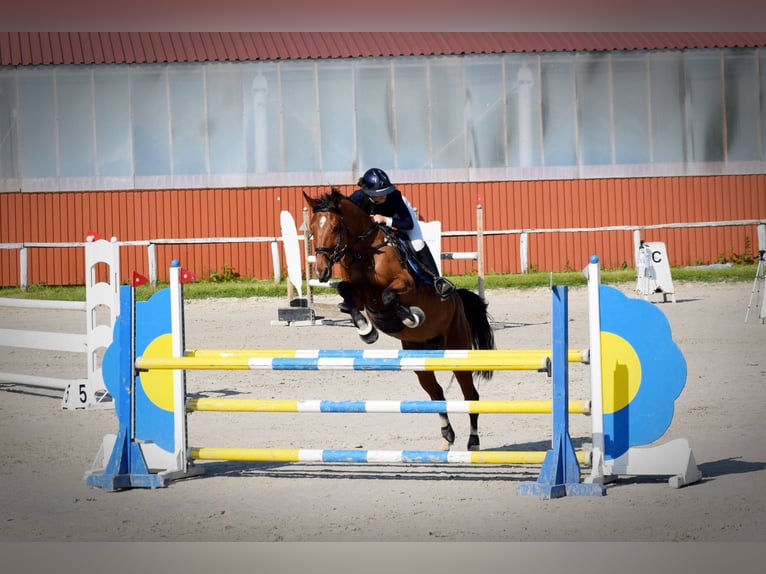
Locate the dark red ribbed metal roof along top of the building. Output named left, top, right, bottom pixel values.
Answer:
left=0, top=32, right=766, bottom=66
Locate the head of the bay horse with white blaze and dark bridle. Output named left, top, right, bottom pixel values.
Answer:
left=303, top=188, right=353, bottom=282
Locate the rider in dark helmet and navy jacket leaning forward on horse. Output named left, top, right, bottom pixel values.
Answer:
left=349, top=167, right=455, bottom=299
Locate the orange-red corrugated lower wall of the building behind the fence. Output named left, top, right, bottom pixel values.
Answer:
left=0, top=175, right=766, bottom=286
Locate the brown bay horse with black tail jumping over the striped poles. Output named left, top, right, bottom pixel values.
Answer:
left=303, top=188, right=495, bottom=450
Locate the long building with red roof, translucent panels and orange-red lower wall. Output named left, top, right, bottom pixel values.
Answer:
left=0, top=33, right=766, bottom=285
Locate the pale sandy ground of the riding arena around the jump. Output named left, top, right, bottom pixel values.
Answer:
left=0, top=282, right=766, bottom=542
